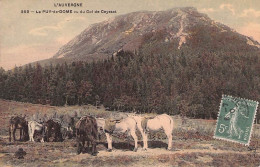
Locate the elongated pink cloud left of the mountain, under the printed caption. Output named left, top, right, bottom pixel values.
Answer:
left=29, top=17, right=85, bottom=36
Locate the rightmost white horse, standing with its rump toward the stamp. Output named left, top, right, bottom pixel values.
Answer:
left=129, top=114, right=174, bottom=150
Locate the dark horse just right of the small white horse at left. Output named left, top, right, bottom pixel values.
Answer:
left=43, top=119, right=63, bottom=142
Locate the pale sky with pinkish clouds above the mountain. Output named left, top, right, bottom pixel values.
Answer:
left=0, top=0, right=260, bottom=70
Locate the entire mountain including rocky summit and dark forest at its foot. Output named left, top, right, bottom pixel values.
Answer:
left=0, top=8, right=260, bottom=119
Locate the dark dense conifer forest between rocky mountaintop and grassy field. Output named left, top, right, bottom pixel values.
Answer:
left=0, top=47, right=260, bottom=119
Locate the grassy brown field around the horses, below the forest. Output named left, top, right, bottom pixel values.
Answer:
left=0, top=100, right=260, bottom=166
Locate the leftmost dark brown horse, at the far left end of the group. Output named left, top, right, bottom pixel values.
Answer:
left=9, top=116, right=29, bottom=142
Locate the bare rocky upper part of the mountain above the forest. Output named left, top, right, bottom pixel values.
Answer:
left=35, top=7, right=260, bottom=64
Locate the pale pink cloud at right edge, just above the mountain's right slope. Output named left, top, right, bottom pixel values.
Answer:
left=237, top=23, right=260, bottom=42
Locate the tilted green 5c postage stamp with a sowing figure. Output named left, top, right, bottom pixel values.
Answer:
left=214, top=95, right=258, bottom=145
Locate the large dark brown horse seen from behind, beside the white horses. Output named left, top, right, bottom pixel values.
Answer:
left=76, top=116, right=98, bottom=156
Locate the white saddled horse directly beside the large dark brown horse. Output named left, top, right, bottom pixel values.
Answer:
left=96, top=117, right=138, bottom=151
